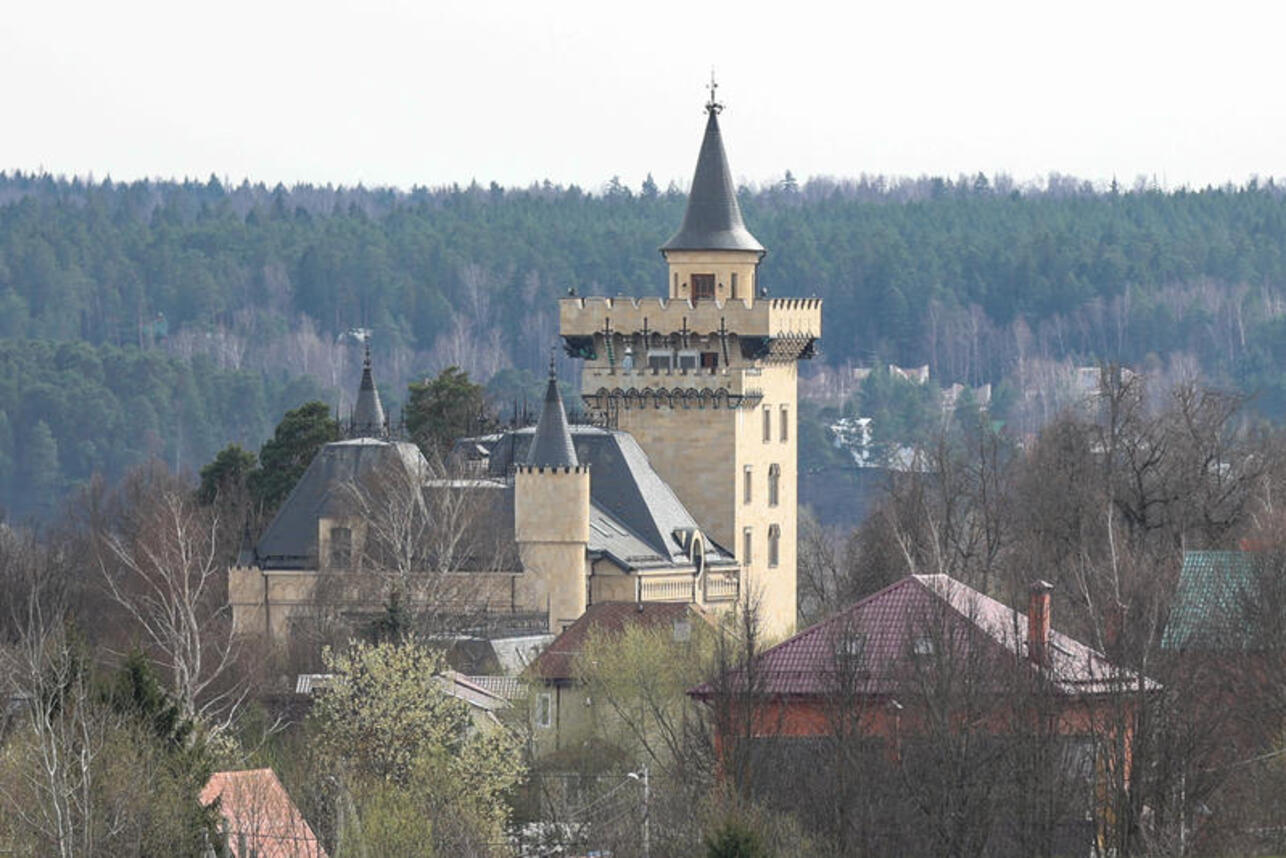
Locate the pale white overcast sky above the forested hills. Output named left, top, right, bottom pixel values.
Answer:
left=0, top=0, right=1286, bottom=189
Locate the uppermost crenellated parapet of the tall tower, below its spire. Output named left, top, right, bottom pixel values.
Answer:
left=558, top=296, right=822, bottom=340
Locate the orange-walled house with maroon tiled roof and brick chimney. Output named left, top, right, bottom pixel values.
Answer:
left=689, top=575, right=1157, bottom=854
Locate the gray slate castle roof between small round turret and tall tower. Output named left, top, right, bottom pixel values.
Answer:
left=457, top=426, right=736, bottom=570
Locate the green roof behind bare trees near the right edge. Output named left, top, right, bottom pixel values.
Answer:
left=1161, top=551, right=1258, bottom=650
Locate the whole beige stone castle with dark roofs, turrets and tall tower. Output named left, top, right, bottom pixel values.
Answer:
left=229, top=96, right=820, bottom=639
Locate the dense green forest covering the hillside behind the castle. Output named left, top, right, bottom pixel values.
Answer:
left=0, top=167, right=1286, bottom=518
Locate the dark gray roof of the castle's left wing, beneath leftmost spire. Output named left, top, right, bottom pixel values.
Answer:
left=255, top=437, right=428, bottom=569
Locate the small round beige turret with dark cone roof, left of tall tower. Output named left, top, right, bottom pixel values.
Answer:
left=513, top=360, right=589, bottom=632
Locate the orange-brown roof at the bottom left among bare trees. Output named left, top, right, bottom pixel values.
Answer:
left=201, top=769, right=327, bottom=858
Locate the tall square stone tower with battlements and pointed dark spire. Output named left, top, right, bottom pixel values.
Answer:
left=559, top=86, right=822, bottom=635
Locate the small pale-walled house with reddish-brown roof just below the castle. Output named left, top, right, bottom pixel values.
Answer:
left=527, top=602, right=710, bottom=754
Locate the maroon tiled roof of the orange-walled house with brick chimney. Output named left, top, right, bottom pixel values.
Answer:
left=693, top=575, right=1156, bottom=697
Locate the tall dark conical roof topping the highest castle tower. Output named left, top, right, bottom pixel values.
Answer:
left=661, top=100, right=764, bottom=253
